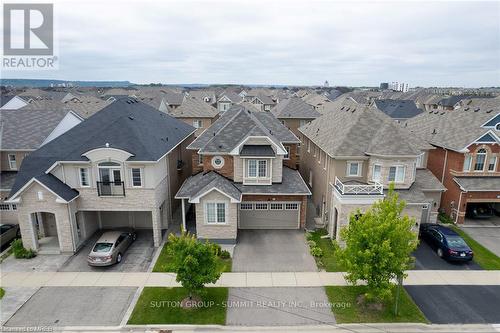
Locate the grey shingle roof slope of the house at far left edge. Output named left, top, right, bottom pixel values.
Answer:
left=0, top=108, right=73, bottom=150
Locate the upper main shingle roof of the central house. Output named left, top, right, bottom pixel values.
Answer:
left=188, top=105, right=299, bottom=153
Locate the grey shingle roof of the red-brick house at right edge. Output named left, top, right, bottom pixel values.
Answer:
left=404, top=98, right=500, bottom=151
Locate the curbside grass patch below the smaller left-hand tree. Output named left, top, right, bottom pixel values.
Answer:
left=128, top=287, right=228, bottom=325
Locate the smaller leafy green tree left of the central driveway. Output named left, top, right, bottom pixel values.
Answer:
left=167, top=233, right=221, bottom=299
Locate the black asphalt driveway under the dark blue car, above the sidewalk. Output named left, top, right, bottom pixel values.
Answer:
left=413, top=240, right=482, bottom=270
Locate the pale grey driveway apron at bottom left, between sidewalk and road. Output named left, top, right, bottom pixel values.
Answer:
left=5, top=287, right=137, bottom=327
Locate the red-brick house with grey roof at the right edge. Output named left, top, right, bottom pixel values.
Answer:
left=405, top=97, right=500, bottom=223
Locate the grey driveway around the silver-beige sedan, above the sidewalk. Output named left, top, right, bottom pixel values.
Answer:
left=59, top=230, right=155, bottom=272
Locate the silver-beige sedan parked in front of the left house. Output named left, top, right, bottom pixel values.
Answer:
left=87, top=229, right=137, bottom=266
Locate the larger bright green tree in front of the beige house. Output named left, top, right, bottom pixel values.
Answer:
left=340, top=185, right=418, bottom=300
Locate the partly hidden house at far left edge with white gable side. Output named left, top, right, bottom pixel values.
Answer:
left=0, top=108, right=82, bottom=223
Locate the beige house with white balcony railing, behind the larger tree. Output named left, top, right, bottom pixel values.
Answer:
left=299, top=101, right=445, bottom=239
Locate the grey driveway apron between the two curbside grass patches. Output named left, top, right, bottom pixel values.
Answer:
left=226, top=287, right=335, bottom=326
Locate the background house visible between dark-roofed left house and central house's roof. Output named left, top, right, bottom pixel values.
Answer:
left=168, top=96, right=219, bottom=136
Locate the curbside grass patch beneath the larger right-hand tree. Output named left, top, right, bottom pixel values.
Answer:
left=325, top=286, right=428, bottom=323
